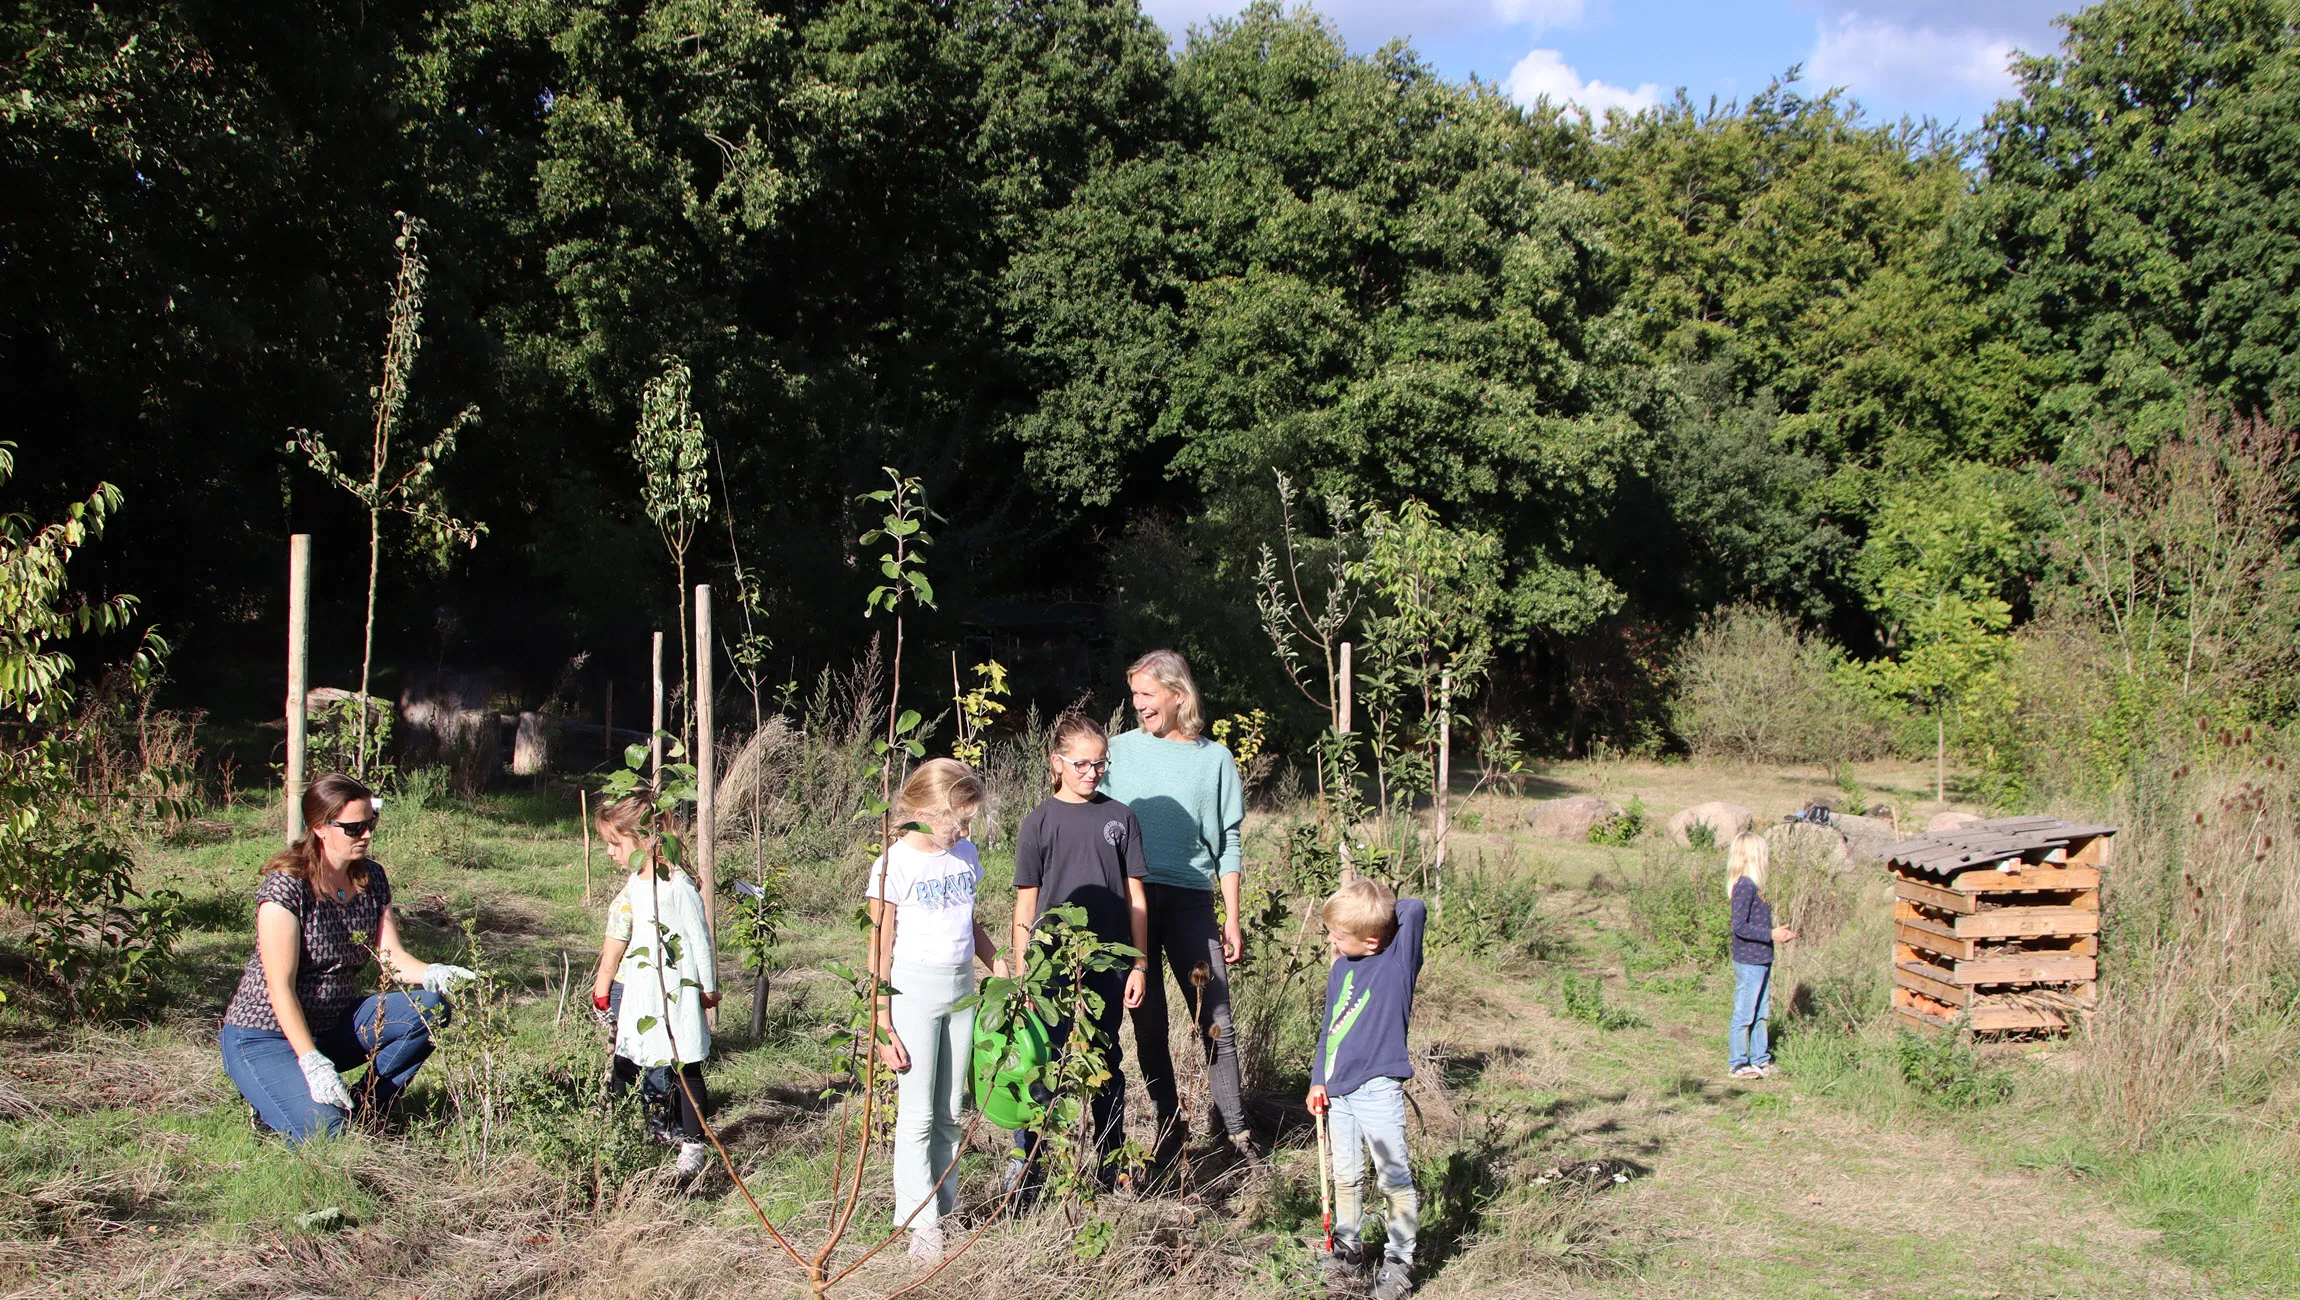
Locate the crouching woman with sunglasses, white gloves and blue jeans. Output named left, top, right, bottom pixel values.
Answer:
left=221, top=773, right=476, bottom=1144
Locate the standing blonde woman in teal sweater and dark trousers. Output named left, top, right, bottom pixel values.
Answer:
left=1102, top=649, right=1256, bottom=1164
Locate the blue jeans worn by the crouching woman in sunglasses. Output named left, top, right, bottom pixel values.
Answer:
left=216, top=989, right=451, bottom=1144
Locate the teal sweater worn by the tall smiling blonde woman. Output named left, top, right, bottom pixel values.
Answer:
left=1102, top=729, right=1247, bottom=890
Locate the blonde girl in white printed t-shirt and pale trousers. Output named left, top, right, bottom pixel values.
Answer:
left=863, top=759, right=1005, bottom=1259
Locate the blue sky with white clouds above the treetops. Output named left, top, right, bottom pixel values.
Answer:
left=1143, top=0, right=2075, bottom=127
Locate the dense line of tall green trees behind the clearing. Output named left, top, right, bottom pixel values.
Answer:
left=0, top=0, right=2300, bottom=745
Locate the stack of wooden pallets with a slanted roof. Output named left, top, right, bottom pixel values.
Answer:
left=1886, top=817, right=2116, bottom=1031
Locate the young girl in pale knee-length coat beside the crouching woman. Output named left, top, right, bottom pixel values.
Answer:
left=591, top=796, right=718, bottom=1178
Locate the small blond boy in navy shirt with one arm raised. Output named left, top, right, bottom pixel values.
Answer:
left=1309, top=879, right=1428, bottom=1300
